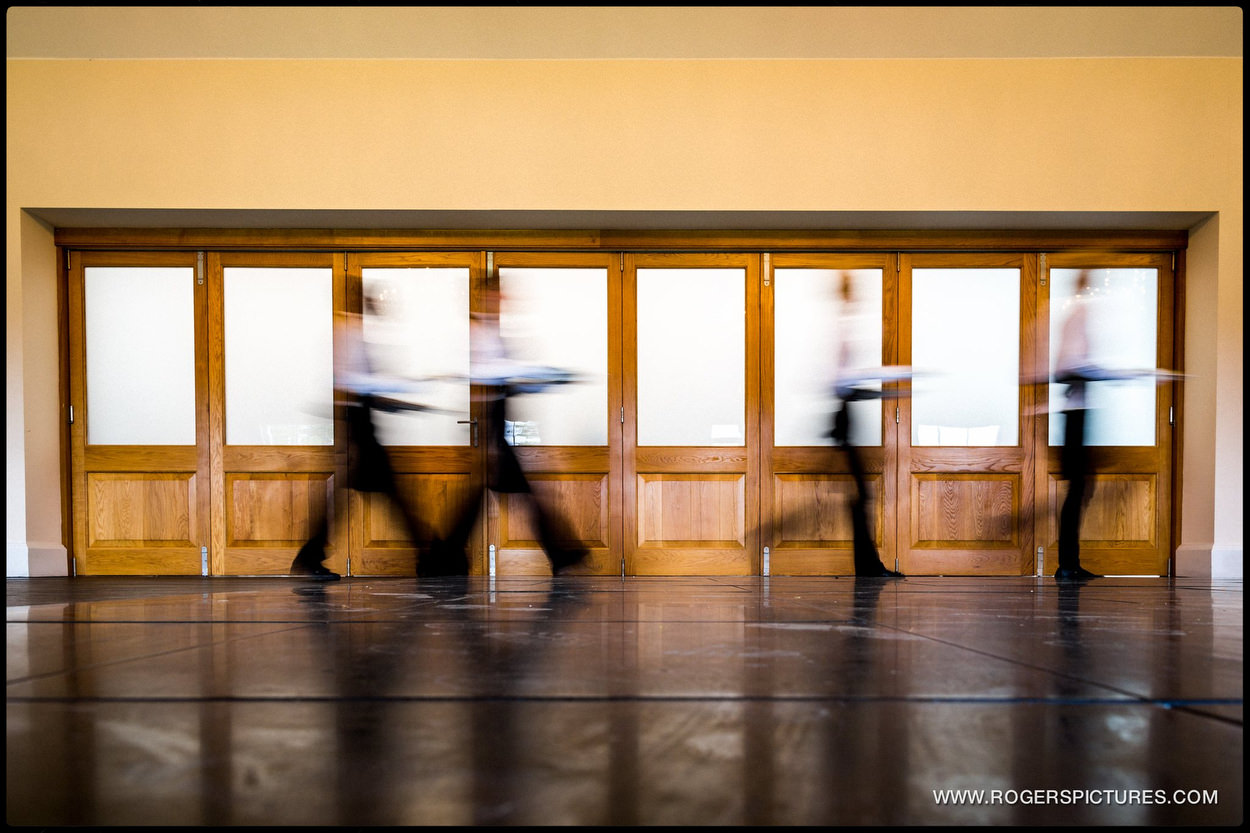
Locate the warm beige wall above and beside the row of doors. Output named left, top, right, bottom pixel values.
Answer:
left=6, top=58, right=1243, bottom=575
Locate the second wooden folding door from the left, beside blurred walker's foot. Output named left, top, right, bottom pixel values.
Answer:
left=206, top=253, right=348, bottom=575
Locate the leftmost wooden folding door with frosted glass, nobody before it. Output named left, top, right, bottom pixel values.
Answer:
left=68, top=251, right=210, bottom=575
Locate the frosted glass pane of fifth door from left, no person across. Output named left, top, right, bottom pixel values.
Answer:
left=638, top=269, right=746, bottom=445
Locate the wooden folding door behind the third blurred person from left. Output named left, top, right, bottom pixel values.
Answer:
left=760, top=253, right=898, bottom=575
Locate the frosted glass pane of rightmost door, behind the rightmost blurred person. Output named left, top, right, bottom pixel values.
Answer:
left=1050, top=269, right=1159, bottom=445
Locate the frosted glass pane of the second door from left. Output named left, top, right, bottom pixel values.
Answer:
left=225, top=268, right=334, bottom=445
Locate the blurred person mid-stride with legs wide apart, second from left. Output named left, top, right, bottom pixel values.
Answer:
left=433, top=283, right=589, bottom=574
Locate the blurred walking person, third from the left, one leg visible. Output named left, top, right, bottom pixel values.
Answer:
left=833, top=271, right=903, bottom=578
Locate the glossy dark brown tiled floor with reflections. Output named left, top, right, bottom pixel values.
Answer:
left=6, top=577, right=1243, bottom=825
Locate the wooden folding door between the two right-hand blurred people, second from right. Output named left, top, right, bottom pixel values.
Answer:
left=896, top=253, right=1038, bottom=575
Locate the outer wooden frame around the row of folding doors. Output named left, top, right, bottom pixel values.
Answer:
left=54, top=228, right=1188, bottom=573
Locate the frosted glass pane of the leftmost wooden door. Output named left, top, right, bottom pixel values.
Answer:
left=83, top=266, right=195, bottom=445
